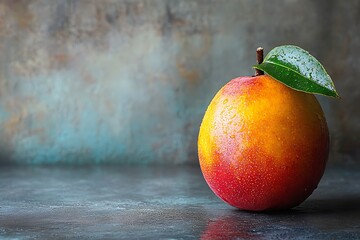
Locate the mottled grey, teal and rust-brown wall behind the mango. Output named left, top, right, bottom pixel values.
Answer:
left=0, top=0, right=360, bottom=164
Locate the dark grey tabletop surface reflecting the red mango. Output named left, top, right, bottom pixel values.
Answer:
left=0, top=166, right=360, bottom=239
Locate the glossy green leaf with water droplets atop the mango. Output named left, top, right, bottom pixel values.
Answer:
left=254, top=45, right=339, bottom=97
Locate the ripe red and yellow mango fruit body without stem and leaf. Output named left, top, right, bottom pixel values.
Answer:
left=198, top=75, right=329, bottom=211
